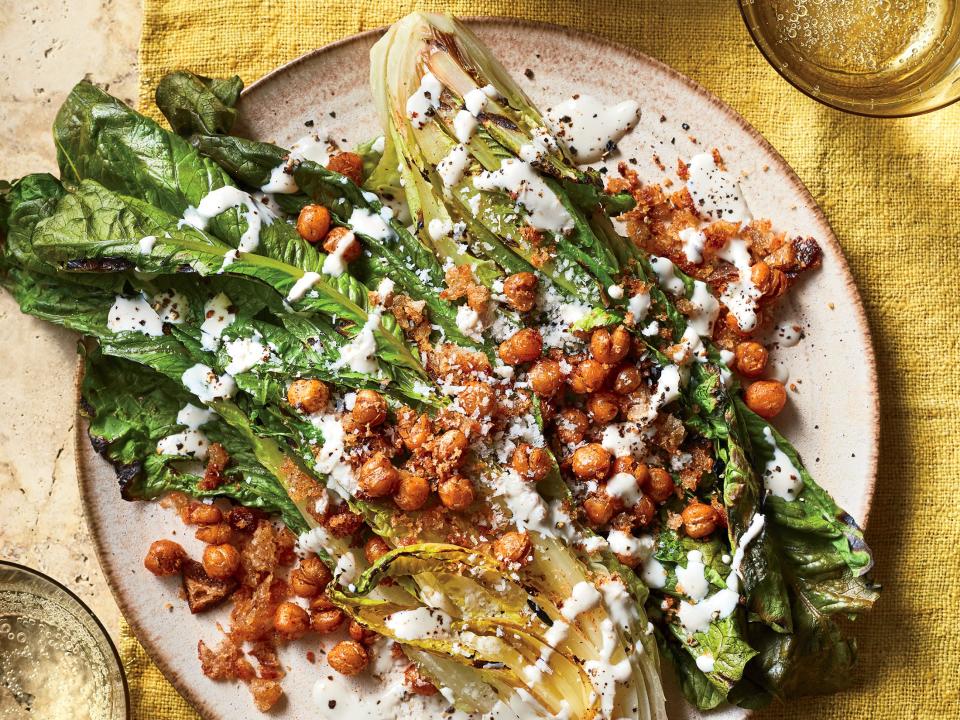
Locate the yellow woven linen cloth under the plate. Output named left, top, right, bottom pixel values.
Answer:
left=133, top=0, right=960, bottom=720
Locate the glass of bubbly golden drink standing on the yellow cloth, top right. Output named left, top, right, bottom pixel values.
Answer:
left=740, top=0, right=960, bottom=117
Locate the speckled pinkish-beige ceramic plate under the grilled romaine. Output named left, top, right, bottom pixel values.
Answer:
left=77, top=18, right=878, bottom=720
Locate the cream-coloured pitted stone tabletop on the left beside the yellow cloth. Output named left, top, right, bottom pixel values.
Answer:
left=0, top=0, right=140, bottom=635
